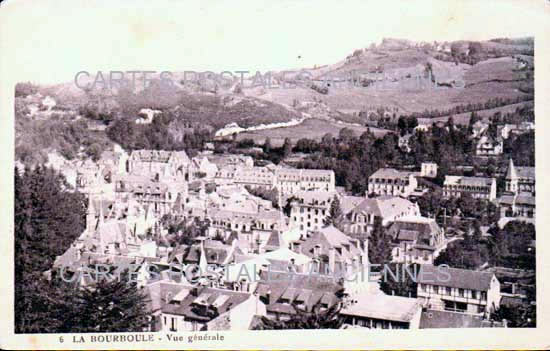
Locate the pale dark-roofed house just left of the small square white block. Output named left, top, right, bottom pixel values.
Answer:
left=368, top=168, right=418, bottom=197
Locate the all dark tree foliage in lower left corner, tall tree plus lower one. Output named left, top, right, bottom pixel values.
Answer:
left=14, top=166, right=153, bottom=333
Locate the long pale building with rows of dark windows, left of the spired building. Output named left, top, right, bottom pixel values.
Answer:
left=443, top=176, right=497, bottom=201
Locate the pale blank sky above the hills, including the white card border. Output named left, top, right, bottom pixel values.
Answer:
left=0, top=0, right=549, bottom=83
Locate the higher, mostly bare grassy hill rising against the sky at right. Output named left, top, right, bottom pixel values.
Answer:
left=249, top=39, right=534, bottom=119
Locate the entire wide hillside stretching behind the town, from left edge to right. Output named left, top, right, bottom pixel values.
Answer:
left=15, top=38, right=534, bottom=162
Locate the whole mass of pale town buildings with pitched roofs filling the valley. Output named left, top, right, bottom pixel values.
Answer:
left=54, top=144, right=512, bottom=332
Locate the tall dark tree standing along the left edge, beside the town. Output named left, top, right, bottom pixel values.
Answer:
left=14, top=166, right=85, bottom=333
